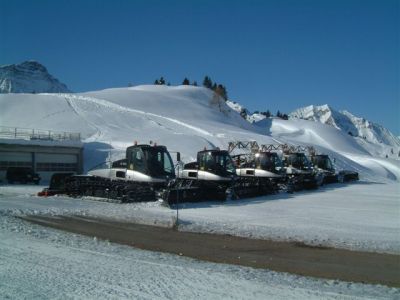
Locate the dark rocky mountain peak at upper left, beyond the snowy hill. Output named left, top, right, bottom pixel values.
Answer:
left=0, top=61, right=69, bottom=94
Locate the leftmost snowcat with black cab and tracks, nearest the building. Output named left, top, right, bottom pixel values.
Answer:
left=65, top=144, right=175, bottom=202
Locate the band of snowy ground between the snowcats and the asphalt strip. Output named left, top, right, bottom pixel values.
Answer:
left=0, top=182, right=400, bottom=254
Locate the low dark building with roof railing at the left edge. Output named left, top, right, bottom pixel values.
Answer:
left=0, top=127, right=83, bottom=182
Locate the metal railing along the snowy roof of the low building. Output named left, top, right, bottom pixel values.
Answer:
left=0, top=126, right=81, bottom=141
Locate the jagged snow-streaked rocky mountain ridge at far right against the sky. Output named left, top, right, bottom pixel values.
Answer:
left=289, top=104, right=400, bottom=149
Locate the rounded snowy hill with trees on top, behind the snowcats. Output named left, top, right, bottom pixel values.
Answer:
left=0, top=85, right=271, bottom=168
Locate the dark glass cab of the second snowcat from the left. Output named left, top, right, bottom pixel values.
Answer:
left=199, top=151, right=236, bottom=176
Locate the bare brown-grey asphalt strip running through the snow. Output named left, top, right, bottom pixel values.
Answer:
left=22, top=215, right=400, bottom=287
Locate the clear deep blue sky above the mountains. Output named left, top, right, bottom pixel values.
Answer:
left=0, top=0, right=400, bottom=135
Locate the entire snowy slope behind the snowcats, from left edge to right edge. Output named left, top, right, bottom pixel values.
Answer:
left=0, top=85, right=400, bottom=181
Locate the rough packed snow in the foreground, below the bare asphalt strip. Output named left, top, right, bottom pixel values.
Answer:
left=0, top=215, right=400, bottom=299
